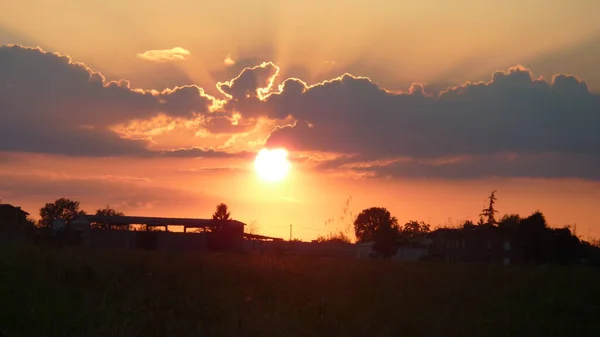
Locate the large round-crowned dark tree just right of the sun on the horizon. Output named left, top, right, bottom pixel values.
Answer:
left=354, top=207, right=400, bottom=257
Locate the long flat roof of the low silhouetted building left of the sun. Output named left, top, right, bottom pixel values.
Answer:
left=71, top=215, right=246, bottom=228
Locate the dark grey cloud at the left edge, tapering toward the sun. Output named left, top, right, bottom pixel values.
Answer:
left=0, top=45, right=213, bottom=156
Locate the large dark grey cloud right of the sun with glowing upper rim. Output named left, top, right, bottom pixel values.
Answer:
left=264, top=67, right=600, bottom=180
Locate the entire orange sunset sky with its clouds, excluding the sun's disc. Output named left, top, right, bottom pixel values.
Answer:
left=0, top=0, right=600, bottom=240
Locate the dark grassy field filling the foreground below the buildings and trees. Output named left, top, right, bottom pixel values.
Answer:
left=0, top=248, right=600, bottom=337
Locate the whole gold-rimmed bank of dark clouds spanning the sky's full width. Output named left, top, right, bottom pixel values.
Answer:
left=0, top=46, right=600, bottom=180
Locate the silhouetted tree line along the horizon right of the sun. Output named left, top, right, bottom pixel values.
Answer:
left=316, top=191, right=600, bottom=264
